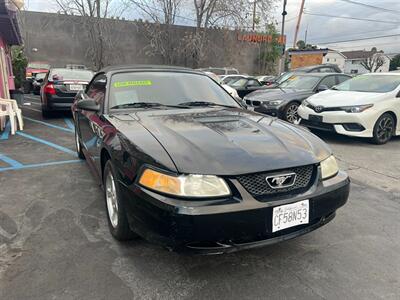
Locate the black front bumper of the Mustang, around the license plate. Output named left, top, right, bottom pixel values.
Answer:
left=122, top=172, right=350, bottom=254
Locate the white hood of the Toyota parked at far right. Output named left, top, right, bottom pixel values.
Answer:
left=307, top=90, right=387, bottom=107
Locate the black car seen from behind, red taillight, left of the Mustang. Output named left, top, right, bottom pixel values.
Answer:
left=40, top=68, right=93, bottom=118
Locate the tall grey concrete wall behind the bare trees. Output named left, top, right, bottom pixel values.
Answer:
left=21, top=12, right=268, bottom=74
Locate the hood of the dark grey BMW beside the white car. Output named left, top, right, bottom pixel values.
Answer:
left=245, top=88, right=313, bottom=101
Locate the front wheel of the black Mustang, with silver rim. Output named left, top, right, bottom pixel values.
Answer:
left=103, top=160, right=137, bottom=241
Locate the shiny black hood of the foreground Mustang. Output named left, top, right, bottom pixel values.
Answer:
left=115, top=108, right=331, bottom=175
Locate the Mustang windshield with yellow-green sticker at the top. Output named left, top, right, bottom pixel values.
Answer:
left=109, top=72, right=240, bottom=107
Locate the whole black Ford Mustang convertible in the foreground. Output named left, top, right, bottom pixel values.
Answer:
left=72, top=66, right=349, bottom=254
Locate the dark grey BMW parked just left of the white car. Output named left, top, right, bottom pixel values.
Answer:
left=244, top=73, right=351, bottom=123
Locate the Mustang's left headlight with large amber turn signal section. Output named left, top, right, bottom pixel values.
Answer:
left=139, top=169, right=231, bottom=198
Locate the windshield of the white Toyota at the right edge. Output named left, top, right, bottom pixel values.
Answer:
left=335, top=75, right=400, bottom=93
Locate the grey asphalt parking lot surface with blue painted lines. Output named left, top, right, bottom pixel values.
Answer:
left=0, top=96, right=400, bottom=299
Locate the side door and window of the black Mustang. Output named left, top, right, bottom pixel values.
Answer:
left=77, top=74, right=107, bottom=165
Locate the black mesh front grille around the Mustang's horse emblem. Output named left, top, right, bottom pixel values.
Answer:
left=237, top=165, right=317, bottom=197
